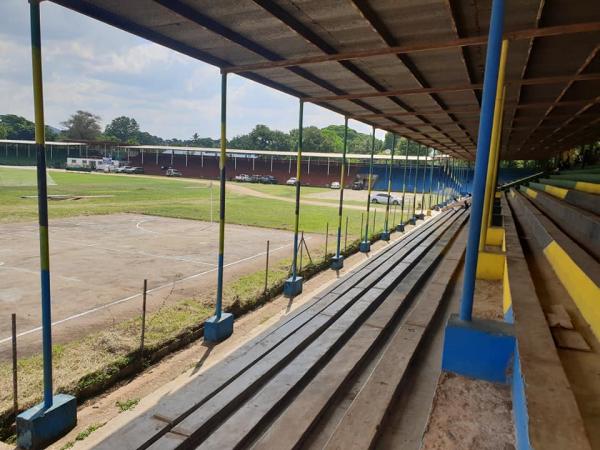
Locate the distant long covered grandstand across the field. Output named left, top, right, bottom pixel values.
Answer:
left=0, top=140, right=535, bottom=192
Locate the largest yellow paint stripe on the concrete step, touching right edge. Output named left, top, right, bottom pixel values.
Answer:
left=544, top=241, right=600, bottom=339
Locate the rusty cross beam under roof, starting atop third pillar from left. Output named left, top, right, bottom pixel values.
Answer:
left=304, top=73, right=600, bottom=103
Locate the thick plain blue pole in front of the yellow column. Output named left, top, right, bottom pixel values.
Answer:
left=460, top=0, right=504, bottom=321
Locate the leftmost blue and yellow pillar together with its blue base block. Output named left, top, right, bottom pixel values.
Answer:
left=16, top=0, right=77, bottom=449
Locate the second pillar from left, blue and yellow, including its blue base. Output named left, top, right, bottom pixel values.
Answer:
left=204, top=73, right=233, bottom=342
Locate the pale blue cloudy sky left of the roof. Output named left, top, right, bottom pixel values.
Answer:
left=0, top=0, right=384, bottom=139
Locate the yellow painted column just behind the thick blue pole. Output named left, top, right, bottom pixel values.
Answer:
left=479, top=39, right=508, bottom=251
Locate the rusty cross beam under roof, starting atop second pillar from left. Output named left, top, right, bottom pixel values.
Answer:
left=223, top=22, right=600, bottom=73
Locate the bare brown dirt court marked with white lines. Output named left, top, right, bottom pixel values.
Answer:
left=0, top=214, right=321, bottom=358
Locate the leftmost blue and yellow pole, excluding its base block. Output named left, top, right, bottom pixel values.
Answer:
left=29, top=0, right=53, bottom=409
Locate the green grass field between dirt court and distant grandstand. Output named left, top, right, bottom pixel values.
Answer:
left=0, top=167, right=420, bottom=236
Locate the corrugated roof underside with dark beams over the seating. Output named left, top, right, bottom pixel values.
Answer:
left=53, top=0, right=600, bottom=159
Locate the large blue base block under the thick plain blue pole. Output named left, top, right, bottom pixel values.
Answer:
left=442, top=314, right=515, bottom=384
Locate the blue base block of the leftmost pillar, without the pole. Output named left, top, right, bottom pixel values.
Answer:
left=17, top=394, right=77, bottom=450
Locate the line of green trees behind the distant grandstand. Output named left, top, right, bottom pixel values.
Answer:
left=0, top=110, right=418, bottom=154
